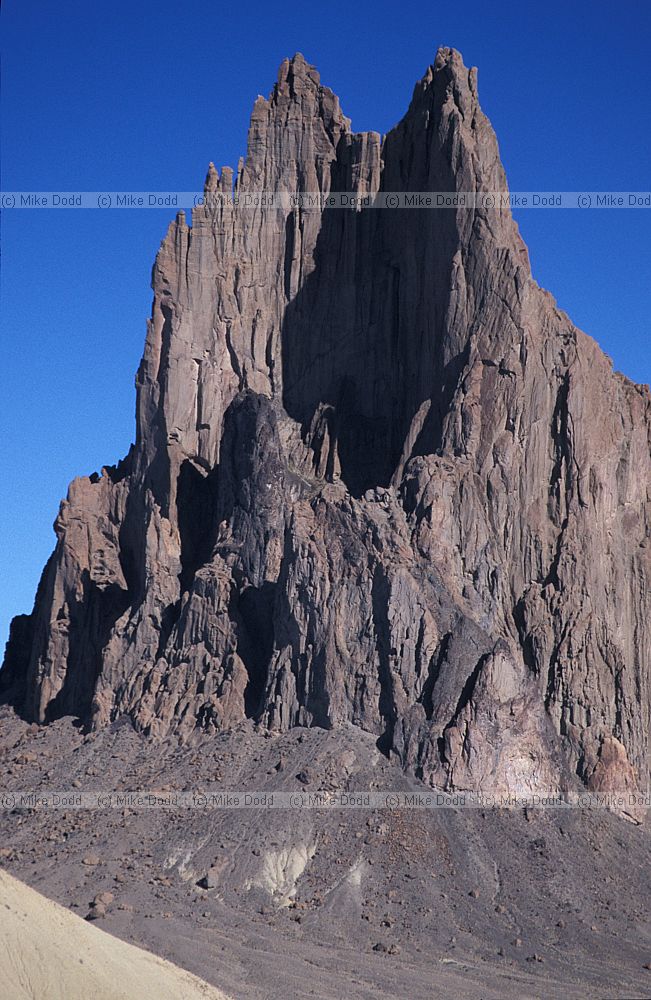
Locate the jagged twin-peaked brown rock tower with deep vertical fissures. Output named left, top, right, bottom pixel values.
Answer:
left=0, top=49, right=651, bottom=804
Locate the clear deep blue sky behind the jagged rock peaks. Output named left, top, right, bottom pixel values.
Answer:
left=0, top=0, right=651, bottom=645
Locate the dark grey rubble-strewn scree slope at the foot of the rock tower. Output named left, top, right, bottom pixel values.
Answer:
left=0, top=709, right=651, bottom=1000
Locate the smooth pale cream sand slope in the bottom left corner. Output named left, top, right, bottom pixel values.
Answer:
left=0, top=870, right=226, bottom=1000
